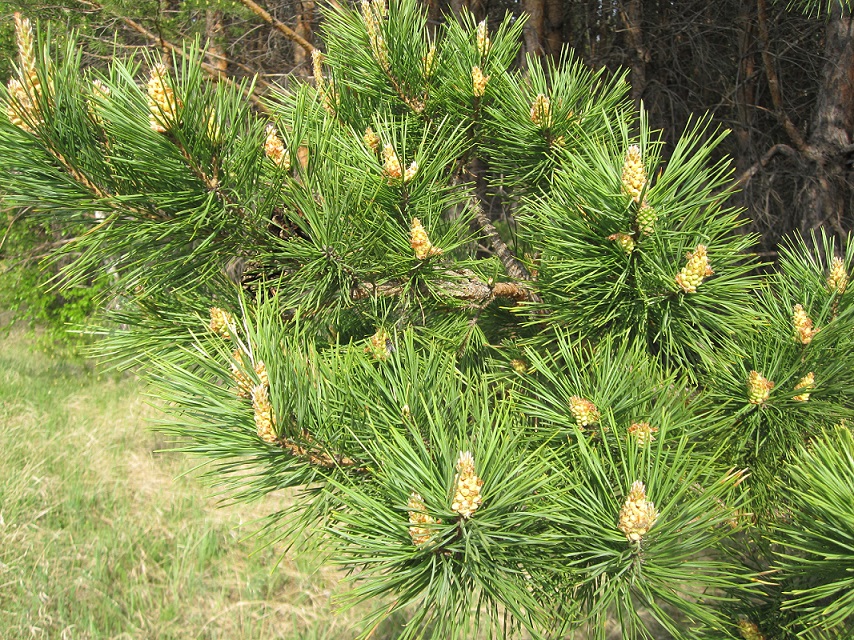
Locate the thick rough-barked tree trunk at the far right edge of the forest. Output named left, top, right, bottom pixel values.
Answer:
left=801, top=3, right=854, bottom=236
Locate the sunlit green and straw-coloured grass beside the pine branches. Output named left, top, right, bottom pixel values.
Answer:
left=0, top=334, right=382, bottom=640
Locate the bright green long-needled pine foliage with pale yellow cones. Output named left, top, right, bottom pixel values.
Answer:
left=0, top=5, right=854, bottom=638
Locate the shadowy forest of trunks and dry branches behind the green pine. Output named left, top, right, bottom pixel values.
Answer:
left=0, top=0, right=854, bottom=259
